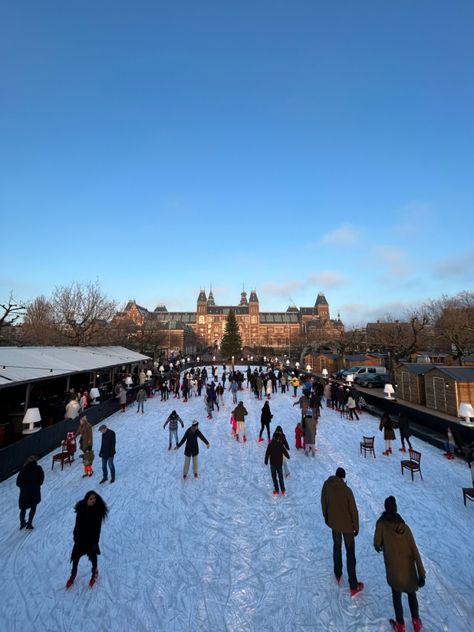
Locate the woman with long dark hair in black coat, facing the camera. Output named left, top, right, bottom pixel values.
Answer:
left=66, top=491, right=109, bottom=588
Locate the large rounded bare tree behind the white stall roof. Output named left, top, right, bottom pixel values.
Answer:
left=51, top=282, right=117, bottom=345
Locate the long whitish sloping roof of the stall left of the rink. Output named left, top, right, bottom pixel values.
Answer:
left=0, top=347, right=149, bottom=387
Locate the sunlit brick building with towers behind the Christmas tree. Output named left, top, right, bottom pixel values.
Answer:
left=117, top=290, right=344, bottom=349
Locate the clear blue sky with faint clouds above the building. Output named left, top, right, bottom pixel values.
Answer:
left=0, top=0, right=474, bottom=324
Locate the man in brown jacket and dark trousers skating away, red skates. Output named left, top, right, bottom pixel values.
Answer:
left=321, top=467, right=364, bottom=597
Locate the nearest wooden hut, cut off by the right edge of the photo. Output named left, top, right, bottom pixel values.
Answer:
left=425, top=366, right=474, bottom=417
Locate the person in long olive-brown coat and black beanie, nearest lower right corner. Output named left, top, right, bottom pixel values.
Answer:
left=374, top=496, right=426, bottom=632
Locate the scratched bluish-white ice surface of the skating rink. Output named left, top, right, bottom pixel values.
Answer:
left=0, top=367, right=474, bottom=632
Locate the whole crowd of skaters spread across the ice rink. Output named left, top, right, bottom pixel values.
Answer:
left=13, top=365, right=474, bottom=632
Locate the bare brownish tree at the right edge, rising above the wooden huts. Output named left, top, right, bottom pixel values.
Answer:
left=428, top=291, right=474, bottom=365
